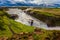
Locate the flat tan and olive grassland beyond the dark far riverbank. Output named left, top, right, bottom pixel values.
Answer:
left=34, top=8, right=60, bottom=15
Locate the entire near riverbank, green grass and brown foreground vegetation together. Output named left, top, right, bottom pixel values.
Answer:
left=0, top=7, right=60, bottom=40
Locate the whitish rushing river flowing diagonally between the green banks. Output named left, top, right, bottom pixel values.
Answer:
left=7, top=8, right=60, bottom=30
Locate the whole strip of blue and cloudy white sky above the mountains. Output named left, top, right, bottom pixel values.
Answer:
left=0, top=0, right=60, bottom=5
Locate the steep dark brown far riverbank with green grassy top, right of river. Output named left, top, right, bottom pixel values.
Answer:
left=25, top=9, right=60, bottom=27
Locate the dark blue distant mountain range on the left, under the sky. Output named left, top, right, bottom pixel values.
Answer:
left=0, top=1, right=38, bottom=6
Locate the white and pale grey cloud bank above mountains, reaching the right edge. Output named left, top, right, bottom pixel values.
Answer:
left=13, top=0, right=60, bottom=5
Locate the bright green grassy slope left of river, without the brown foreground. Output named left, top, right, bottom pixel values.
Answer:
left=0, top=11, right=34, bottom=36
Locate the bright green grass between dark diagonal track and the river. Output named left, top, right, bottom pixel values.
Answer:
left=11, top=20, right=34, bottom=33
